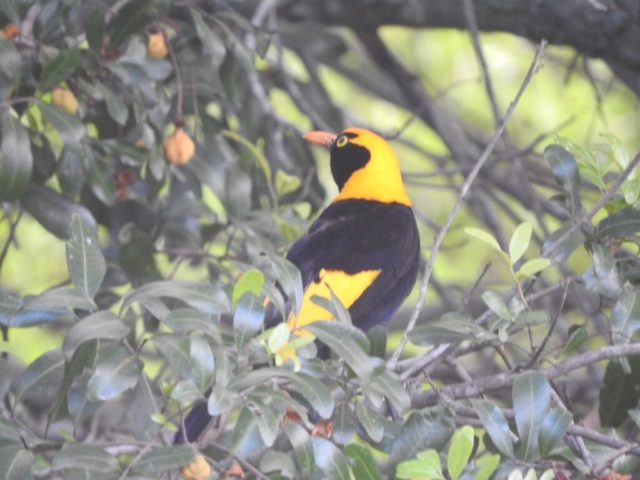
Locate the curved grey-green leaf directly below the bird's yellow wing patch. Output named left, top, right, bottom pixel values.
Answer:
left=304, top=321, right=373, bottom=381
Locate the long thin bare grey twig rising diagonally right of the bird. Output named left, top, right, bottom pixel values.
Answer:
left=390, top=42, right=545, bottom=364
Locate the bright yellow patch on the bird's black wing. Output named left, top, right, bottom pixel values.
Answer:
left=287, top=269, right=381, bottom=335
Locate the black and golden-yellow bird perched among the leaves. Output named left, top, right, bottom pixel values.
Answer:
left=174, top=127, right=420, bottom=443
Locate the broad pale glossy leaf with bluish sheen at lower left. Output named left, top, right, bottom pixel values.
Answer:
left=87, top=347, right=143, bottom=401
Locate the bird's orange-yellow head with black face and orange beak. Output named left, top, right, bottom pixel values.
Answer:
left=304, top=128, right=411, bottom=206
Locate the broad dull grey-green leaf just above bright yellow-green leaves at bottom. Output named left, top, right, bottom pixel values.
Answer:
left=389, top=407, right=455, bottom=472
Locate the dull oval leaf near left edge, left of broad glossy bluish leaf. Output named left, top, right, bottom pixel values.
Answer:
left=15, top=350, right=64, bottom=404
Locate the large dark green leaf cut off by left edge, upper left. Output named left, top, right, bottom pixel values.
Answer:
left=0, top=108, right=33, bottom=201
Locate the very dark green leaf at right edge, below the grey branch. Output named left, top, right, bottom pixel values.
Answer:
left=599, top=356, right=640, bottom=428
